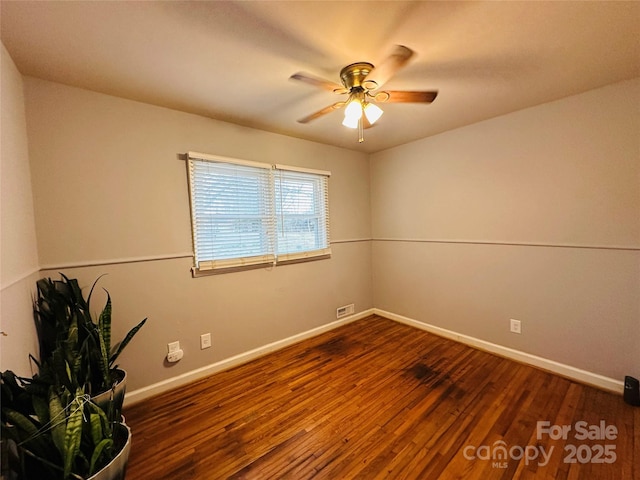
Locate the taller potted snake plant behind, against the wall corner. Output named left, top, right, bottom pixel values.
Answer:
left=31, top=274, right=147, bottom=420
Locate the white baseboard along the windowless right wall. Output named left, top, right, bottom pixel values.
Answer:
left=373, top=308, right=624, bottom=394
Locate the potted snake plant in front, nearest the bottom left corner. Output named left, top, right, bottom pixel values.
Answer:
left=1, top=370, right=131, bottom=480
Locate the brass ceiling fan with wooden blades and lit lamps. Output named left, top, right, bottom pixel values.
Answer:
left=290, top=45, right=438, bottom=142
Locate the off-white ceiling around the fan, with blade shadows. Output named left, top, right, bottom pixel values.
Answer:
left=0, top=0, right=640, bottom=152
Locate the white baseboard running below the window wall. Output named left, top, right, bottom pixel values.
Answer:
left=125, top=308, right=374, bottom=406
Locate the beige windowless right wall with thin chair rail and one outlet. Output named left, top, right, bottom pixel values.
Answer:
left=371, top=80, right=640, bottom=380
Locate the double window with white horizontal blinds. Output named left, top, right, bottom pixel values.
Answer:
left=188, top=152, right=331, bottom=275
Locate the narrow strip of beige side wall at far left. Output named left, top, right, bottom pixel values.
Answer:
left=0, top=45, right=38, bottom=375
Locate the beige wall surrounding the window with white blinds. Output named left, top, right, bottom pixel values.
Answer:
left=25, top=78, right=372, bottom=389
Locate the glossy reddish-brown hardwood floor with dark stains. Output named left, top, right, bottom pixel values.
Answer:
left=125, top=316, right=640, bottom=480
